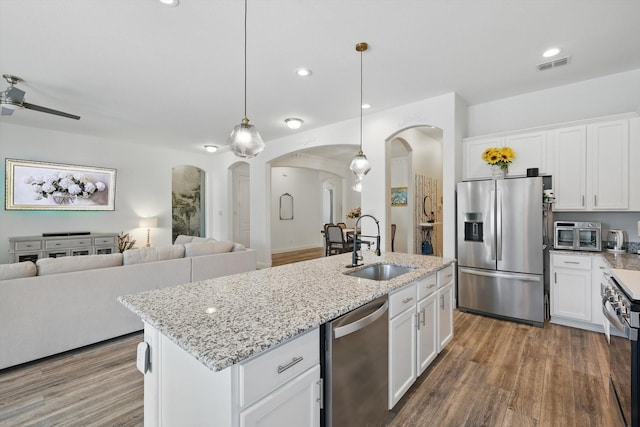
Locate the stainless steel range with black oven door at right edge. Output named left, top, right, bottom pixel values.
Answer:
left=601, top=273, right=640, bottom=427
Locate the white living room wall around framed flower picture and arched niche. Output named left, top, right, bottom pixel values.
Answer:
left=0, top=122, right=222, bottom=263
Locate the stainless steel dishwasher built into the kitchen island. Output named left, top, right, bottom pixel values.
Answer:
left=321, top=295, right=389, bottom=427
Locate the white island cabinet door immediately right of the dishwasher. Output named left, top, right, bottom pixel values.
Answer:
left=389, top=305, right=417, bottom=409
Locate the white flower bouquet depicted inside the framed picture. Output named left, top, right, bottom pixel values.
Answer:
left=24, top=172, right=107, bottom=200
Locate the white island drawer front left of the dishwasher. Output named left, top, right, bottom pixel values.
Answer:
left=239, top=328, right=320, bottom=407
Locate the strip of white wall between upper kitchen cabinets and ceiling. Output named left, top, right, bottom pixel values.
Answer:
left=467, top=69, right=640, bottom=136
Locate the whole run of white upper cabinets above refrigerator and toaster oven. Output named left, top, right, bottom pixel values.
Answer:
left=462, top=114, right=640, bottom=211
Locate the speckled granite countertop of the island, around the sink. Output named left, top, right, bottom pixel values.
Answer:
left=118, top=251, right=455, bottom=371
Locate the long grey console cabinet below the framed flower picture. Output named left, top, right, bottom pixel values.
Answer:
left=9, top=233, right=118, bottom=262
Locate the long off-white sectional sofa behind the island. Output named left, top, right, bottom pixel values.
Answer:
left=0, top=236, right=256, bottom=369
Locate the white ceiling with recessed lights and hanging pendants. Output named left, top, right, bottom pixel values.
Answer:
left=0, top=0, right=640, bottom=154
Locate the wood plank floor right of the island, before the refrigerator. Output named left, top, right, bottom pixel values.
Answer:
left=388, top=311, right=617, bottom=427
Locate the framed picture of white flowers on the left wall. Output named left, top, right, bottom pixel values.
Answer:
left=5, top=159, right=116, bottom=211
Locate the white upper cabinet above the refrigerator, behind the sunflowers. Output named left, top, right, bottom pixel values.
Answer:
left=463, top=131, right=548, bottom=180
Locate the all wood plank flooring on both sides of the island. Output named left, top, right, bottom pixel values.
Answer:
left=0, top=311, right=616, bottom=427
